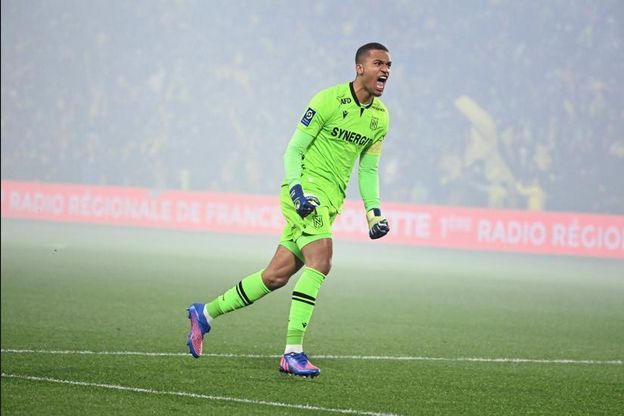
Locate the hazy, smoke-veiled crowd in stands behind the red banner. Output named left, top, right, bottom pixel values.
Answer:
left=1, top=0, right=624, bottom=215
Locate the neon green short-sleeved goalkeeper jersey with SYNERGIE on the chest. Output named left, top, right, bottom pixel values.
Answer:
left=289, top=82, right=389, bottom=209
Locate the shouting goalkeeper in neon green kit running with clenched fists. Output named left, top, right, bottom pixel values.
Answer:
left=187, top=43, right=391, bottom=377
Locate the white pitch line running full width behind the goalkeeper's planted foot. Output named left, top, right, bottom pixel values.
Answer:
left=0, top=348, right=624, bottom=365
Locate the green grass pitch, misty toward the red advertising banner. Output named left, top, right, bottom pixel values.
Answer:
left=1, top=221, right=624, bottom=416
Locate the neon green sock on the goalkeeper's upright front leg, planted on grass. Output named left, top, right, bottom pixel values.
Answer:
left=286, top=267, right=325, bottom=345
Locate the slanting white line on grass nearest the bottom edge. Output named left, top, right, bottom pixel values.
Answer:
left=2, top=373, right=398, bottom=416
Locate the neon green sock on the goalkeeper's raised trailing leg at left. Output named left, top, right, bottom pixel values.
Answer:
left=206, top=270, right=270, bottom=319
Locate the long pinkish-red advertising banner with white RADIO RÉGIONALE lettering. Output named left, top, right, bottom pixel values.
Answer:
left=2, top=181, right=624, bottom=259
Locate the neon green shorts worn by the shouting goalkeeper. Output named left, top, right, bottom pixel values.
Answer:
left=280, top=185, right=338, bottom=261
